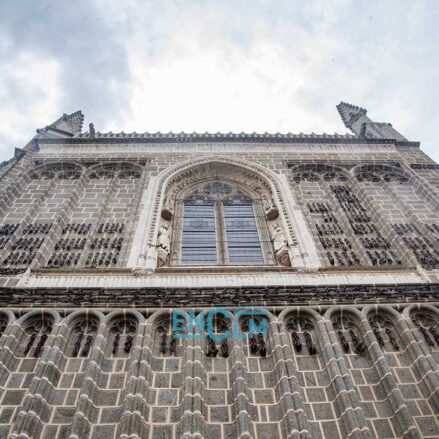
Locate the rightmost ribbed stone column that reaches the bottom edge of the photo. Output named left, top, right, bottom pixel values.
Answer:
left=359, top=318, right=421, bottom=439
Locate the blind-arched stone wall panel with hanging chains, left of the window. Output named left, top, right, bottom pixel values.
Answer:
left=0, top=162, right=143, bottom=274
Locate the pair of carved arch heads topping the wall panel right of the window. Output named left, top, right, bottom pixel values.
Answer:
left=291, top=163, right=410, bottom=183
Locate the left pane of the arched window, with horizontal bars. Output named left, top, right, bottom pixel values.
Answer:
left=181, top=201, right=218, bottom=265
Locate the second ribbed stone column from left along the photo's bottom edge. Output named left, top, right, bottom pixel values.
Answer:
left=69, top=323, right=108, bottom=439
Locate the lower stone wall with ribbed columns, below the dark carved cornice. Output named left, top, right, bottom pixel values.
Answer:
left=0, top=298, right=439, bottom=439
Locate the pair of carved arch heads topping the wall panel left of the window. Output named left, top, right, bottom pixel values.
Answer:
left=31, top=162, right=143, bottom=180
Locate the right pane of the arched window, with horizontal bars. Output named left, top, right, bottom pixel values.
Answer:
left=224, top=200, right=264, bottom=265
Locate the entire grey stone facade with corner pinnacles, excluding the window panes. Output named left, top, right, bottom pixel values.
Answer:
left=0, top=103, right=439, bottom=439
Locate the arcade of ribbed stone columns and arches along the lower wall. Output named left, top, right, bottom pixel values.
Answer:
left=0, top=305, right=439, bottom=438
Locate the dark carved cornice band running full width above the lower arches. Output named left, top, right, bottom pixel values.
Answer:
left=0, top=284, right=439, bottom=308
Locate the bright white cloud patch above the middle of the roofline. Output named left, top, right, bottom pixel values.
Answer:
left=107, top=0, right=350, bottom=136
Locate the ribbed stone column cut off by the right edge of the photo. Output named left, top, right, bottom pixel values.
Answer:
left=395, top=318, right=439, bottom=414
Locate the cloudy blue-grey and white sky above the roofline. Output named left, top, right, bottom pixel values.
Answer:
left=0, top=0, right=439, bottom=161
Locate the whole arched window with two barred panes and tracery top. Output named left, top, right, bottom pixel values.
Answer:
left=171, top=181, right=273, bottom=265
